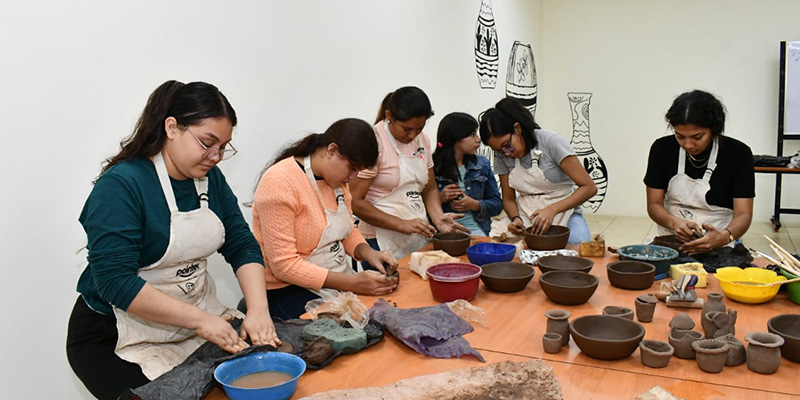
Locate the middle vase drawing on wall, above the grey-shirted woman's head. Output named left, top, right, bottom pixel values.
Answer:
left=506, top=40, right=537, bottom=116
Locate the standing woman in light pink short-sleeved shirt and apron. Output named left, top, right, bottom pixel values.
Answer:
left=351, top=86, right=469, bottom=268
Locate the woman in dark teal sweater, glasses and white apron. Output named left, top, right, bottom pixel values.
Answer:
left=67, top=81, right=280, bottom=399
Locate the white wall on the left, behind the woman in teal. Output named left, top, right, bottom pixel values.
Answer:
left=0, top=0, right=542, bottom=399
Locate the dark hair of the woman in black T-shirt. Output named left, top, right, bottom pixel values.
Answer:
left=664, top=90, right=725, bottom=137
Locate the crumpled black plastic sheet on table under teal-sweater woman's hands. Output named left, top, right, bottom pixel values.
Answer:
left=131, top=319, right=384, bottom=400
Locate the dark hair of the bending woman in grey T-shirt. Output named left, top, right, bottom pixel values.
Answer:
left=480, top=97, right=542, bottom=152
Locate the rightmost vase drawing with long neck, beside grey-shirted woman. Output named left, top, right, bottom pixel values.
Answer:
left=567, top=92, right=608, bottom=212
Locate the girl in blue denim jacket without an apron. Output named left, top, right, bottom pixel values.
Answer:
left=433, top=112, right=503, bottom=236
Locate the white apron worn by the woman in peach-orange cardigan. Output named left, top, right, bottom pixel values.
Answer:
left=303, top=157, right=355, bottom=300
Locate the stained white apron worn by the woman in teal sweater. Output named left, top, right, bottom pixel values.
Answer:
left=114, top=153, right=242, bottom=380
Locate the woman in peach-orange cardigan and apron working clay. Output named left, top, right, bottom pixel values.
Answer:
left=252, top=118, right=398, bottom=319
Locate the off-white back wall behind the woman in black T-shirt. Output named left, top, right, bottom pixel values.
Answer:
left=537, top=0, right=800, bottom=223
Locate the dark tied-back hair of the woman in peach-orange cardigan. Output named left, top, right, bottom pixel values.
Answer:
left=265, top=118, right=378, bottom=170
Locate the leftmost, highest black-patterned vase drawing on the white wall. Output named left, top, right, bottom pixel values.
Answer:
left=475, top=0, right=500, bottom=89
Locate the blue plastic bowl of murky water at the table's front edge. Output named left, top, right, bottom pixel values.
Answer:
left=214, top=351, right=306, bottom=400
